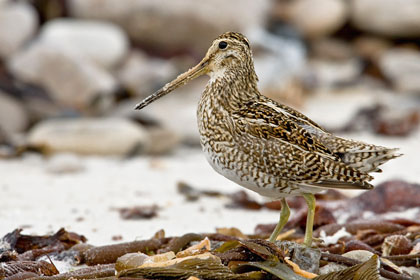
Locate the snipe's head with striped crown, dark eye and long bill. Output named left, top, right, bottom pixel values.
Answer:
left=135, top=32, right=253, bottom=110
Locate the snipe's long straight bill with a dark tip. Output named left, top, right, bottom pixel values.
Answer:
left=135, top=57, right=209, bottom=110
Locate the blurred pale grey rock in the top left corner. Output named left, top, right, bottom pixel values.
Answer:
left=0, top=1, right=38, bottom=58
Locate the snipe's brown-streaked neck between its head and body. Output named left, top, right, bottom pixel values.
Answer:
left=202, top=67, right=261, bottom=109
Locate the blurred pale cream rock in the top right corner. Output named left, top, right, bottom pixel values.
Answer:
left=350, top=0, right=420, bottom=37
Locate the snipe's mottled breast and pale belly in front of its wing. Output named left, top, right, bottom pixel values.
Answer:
left=197, top=95, right=283, bottom=198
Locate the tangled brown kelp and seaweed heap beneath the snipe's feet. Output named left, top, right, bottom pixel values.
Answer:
left=0, top=225, right=420, bottom=280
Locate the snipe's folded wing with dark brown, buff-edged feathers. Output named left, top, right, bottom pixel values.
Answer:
left=230, top=102, right=372, bottom=188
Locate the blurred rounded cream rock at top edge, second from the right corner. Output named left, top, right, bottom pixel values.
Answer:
left=288, top=0, right=348, bottom=38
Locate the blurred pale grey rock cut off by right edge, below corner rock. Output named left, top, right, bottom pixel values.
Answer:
left=379, top=49, right=420, bottom=94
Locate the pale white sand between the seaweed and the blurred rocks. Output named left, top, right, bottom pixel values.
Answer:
left=0, top=91, right=420, bottom=245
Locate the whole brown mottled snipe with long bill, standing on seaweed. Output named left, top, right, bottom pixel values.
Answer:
left=136, top=32, right=399, bottom=246
